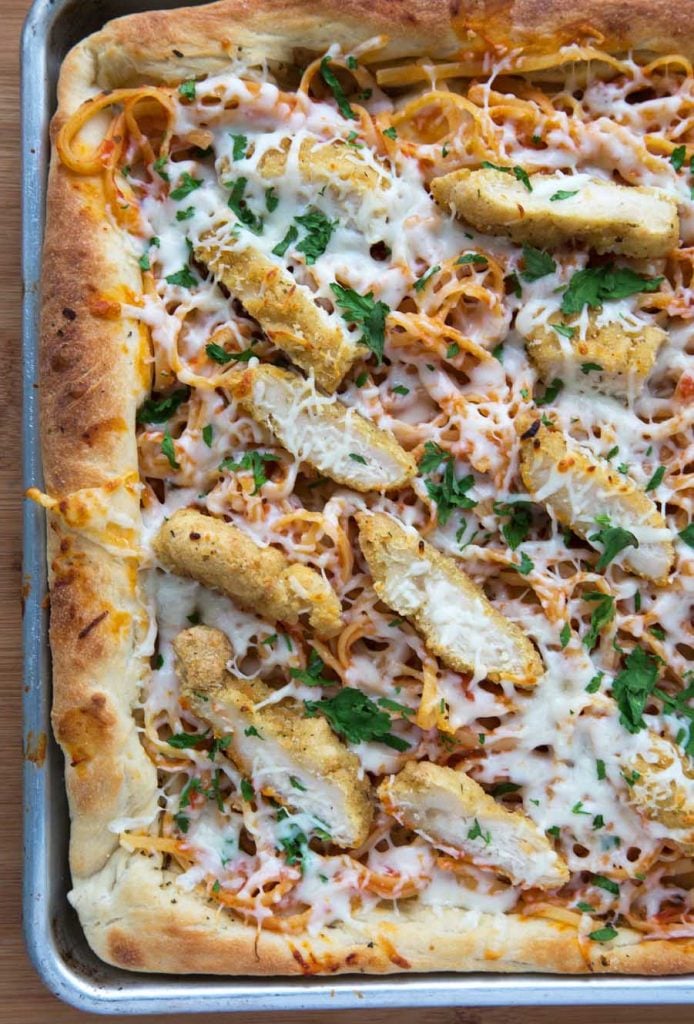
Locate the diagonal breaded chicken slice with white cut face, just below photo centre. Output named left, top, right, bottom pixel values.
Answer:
left=356, top=512, right=544, bottom=687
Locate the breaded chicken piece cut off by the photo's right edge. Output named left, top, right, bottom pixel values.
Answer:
left=622, top=732, right=694, bottom=855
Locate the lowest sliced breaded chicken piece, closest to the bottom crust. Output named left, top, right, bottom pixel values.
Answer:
left=378, top=761, right=569, bottom=889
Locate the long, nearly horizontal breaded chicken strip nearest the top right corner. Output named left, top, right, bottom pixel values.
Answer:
left=431, top=168, right=680, bottom=257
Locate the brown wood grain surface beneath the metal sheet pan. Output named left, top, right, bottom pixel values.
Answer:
left=0, top=0, right=694, bottom=1024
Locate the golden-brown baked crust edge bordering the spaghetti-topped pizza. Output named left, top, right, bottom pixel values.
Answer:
left=41, top=0, right=694, bottom=975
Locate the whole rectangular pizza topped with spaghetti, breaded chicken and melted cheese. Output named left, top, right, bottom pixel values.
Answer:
left=31, top=0, right=694, bottom=975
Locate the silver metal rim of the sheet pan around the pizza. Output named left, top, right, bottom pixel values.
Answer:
left=21, top=0, right=694, bottom=1015
